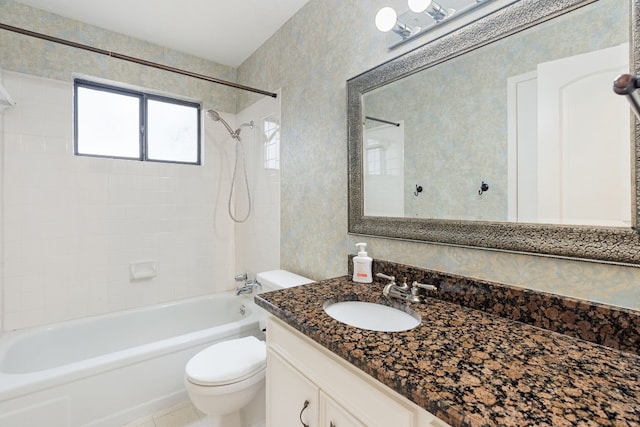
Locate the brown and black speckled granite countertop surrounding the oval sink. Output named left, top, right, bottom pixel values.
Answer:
left=255, top=276, right=640, bottom=427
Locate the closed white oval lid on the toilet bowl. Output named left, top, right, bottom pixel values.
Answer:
left=185, top=336, right=267, bottom=386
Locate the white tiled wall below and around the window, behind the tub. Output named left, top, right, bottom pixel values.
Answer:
left=2, top=72, right=241, bottom=330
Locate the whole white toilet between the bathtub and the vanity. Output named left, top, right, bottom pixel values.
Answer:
left=184, top=270, right=313, bottom=427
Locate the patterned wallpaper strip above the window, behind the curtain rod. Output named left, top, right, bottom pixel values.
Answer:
left=0, top=0, right=238, bottom=113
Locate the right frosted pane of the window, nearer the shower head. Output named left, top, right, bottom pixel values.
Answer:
left=147, top=99, right=198, bottom=163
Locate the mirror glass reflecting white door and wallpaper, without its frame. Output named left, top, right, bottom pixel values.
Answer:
left=362, top=0, right=632, bottom=228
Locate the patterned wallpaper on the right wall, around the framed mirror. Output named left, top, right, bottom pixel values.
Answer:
left=238, top=0, right=640, bottom=309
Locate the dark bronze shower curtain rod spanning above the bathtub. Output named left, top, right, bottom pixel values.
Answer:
left=0, top=22, right=278, bottom=98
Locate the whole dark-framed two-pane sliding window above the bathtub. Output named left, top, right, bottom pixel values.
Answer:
left=74, top=80, right=200, bottom=164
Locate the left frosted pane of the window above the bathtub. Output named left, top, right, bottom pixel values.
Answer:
left=76, top=87, right=140, bottom=158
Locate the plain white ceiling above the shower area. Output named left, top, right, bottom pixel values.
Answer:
left=10, top=0, right=309, bottom=68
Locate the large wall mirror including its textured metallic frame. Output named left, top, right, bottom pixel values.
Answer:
left=347, top=0, right=640, bottom=265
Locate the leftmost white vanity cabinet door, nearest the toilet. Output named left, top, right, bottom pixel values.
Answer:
left=267, top=349, right=319, bottom=427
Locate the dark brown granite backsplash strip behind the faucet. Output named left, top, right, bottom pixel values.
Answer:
left=348, top=255, right=640, bottom=354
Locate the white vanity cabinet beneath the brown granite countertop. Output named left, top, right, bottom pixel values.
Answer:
left=267, top=317, right=448, bottom=427
